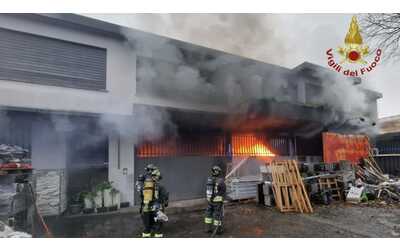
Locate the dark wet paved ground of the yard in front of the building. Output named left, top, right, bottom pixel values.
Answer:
left=43, top=202, right=400, bottom=238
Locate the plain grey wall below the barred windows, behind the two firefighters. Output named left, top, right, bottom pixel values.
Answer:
left=135, top=156, right=226, bottom=204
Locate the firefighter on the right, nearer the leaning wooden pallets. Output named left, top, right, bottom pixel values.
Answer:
left=204, top=166, right=226, bottom=234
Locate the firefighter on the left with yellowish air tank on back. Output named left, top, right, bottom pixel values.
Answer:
left=138, top=164, right=168, bottom=238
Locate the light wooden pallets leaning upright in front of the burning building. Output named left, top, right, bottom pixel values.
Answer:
left=270, top=160, right=313, bottom=213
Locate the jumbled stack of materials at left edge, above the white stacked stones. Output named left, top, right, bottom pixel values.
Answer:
left=0, top=144, right=32, bottom=170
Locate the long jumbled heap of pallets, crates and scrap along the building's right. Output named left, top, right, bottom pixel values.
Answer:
left=259, top=155, right=400, bottom=209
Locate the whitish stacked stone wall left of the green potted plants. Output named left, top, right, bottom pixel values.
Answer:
left=34, top=169, right=67, bottom=216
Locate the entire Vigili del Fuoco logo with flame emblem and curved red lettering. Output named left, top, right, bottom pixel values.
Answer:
left=326, top=16, right=382, bottom=77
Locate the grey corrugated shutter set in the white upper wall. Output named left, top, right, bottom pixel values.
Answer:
left=0, top=28, right=107, bottom=90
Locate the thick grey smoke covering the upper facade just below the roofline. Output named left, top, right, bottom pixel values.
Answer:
left=123, top=25, right=287, bottom=109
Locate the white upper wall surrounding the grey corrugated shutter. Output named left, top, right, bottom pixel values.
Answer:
left=0, top=14, right=136, bottom=114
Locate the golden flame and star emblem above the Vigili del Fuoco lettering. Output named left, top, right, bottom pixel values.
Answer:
left=338, top=16, right=369, bottom=64
